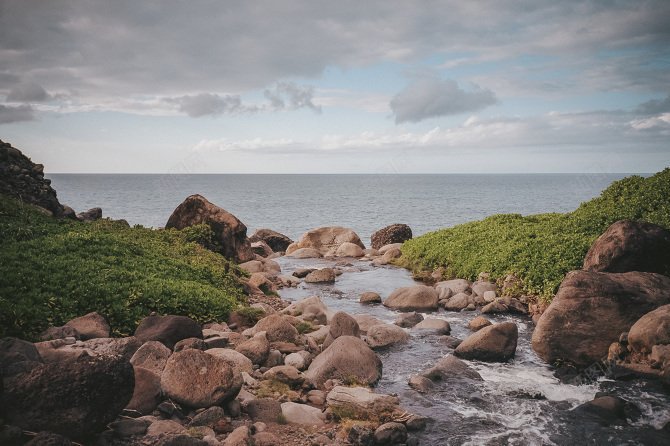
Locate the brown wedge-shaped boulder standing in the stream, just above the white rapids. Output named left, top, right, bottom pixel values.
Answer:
left=454, top=322, right=519, bottom=362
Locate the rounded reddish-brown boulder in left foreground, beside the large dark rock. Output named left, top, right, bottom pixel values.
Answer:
left=161, top=349, right=242, bottom=408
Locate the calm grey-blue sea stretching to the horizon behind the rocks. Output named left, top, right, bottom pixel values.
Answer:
left=47, top=174, right=627, bottom=244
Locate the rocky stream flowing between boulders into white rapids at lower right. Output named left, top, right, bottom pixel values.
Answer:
left=275, top=257, right=670, bottom=445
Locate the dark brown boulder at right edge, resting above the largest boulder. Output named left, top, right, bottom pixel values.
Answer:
left=583, top=220, right=670, bottom=275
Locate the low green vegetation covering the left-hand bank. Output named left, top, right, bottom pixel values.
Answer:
left=0, top=196, right=245, bottom=339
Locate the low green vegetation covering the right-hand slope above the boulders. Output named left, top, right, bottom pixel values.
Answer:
left=399, top=168, right=670, bottom=300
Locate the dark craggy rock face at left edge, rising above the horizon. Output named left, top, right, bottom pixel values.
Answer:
left=0, top=140, right=65, bottom=217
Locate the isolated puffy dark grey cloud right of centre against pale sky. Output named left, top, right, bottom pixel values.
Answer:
left=389, top=76, right=498, bottom=123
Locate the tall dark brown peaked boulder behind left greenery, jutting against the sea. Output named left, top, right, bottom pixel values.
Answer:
left=165, top=195, right=254, bottom=263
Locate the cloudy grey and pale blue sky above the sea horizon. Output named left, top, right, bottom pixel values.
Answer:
left=0, top=0, right=670, bottom=173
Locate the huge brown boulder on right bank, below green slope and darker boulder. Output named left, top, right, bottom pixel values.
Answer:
left=532, top=271, right=670, bottom=366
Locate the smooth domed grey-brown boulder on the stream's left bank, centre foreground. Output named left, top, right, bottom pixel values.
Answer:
left=305, top=336, right=382, bottom=387
